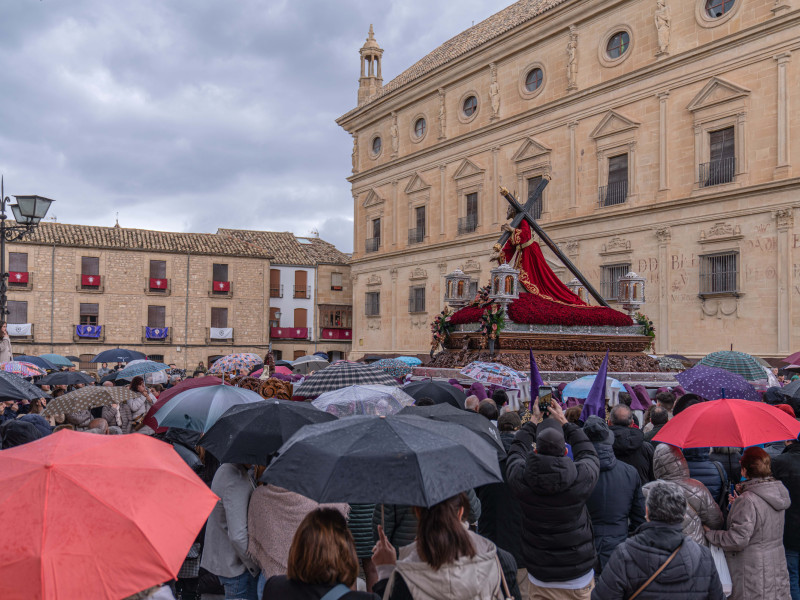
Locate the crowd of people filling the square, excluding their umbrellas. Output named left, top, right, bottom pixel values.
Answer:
left=0, top=342, right=800, bottom=600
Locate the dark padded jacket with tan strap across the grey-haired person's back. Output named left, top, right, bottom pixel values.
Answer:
left=592, top=521, right=724, bottom=600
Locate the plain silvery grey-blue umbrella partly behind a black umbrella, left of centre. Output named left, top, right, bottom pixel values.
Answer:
left=153, top=385, right=264, bottom=431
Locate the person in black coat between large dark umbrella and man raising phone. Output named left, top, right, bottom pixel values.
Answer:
left=475, top=431, right=522, bottom=564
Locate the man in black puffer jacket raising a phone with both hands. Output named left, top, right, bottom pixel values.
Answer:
left=506, top=401, right=600, bottom=600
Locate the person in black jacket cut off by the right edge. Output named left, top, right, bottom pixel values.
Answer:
left=772, top=440, right=800, bottom=600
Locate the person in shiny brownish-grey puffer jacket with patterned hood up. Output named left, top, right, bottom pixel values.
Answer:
left=642, top=444, right=725, bottom=546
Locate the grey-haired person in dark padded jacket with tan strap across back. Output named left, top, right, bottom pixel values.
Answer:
left=592, top=481, right=724, bottom=600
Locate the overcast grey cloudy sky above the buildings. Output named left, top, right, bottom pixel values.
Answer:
left=0, top=0, right=510, bottom=251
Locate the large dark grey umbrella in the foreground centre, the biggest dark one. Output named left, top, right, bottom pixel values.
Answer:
left=263, top=415, right=502, bottom=507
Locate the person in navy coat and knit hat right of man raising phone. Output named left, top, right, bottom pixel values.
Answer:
left=583, top=415, right=644, bottom=570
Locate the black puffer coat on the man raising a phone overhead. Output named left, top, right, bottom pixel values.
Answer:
left=506, top=422, right=600, bottom=581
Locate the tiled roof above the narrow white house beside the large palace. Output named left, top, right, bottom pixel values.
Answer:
left=217, top=229, right=349, bottom=265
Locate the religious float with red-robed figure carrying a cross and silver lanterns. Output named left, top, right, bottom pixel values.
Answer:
left=427, top=177, right=661, bottom=373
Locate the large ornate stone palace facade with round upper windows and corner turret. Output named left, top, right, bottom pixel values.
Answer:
left=337, top=0, right=800, bottom=357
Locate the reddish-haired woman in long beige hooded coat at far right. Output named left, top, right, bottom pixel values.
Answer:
left=705, top=447, right=791, bottom=600
